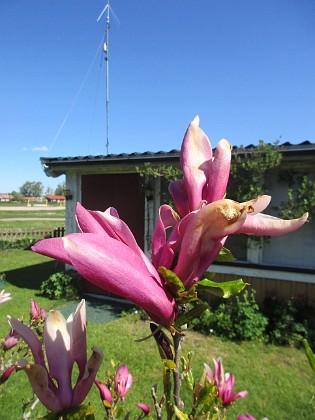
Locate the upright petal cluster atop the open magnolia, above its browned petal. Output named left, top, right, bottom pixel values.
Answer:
left=169, top=116, right=232, bottom=217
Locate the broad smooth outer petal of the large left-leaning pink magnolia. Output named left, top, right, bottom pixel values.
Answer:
left=64, top=233, right=176, bottom=327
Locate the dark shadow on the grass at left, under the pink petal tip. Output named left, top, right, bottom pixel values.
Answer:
left=3, top=261, right=64, bottom=290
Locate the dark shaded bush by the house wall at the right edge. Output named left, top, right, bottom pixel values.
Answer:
left=264, top=296, right=314, bottom=346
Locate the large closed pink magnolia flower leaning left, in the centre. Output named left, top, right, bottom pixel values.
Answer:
left=32, top=203, right=177, bottom=327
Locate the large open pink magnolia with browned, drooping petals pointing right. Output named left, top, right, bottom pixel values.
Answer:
left=152, top=117, right=308, bottom=288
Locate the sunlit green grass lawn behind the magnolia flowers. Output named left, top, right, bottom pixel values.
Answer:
left=0, top=251, right=315, bottom=420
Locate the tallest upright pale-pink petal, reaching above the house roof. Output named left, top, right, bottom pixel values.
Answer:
left=180, top=117, right=212, bottom=211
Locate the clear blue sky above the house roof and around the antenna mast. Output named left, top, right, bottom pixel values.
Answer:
left=0, top=0, right=315, bottom=193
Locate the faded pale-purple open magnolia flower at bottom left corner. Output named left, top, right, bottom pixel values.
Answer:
left=9, top=300, right=103, bottom=413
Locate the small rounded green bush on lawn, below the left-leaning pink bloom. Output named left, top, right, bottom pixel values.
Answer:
left=40, top=272, right=82, bottom=299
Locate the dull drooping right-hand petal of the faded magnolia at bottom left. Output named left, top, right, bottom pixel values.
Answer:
left=71, top=347, right=104, bottom=407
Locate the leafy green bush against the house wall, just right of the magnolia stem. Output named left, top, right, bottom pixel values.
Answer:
left=193, top=290, right=268, bottom=340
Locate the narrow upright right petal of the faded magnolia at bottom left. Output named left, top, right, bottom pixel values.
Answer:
left=67, top=299, right=87, bottom=381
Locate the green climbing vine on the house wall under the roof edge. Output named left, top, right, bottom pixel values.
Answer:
left=137, top=140, right=315, bottom=219
